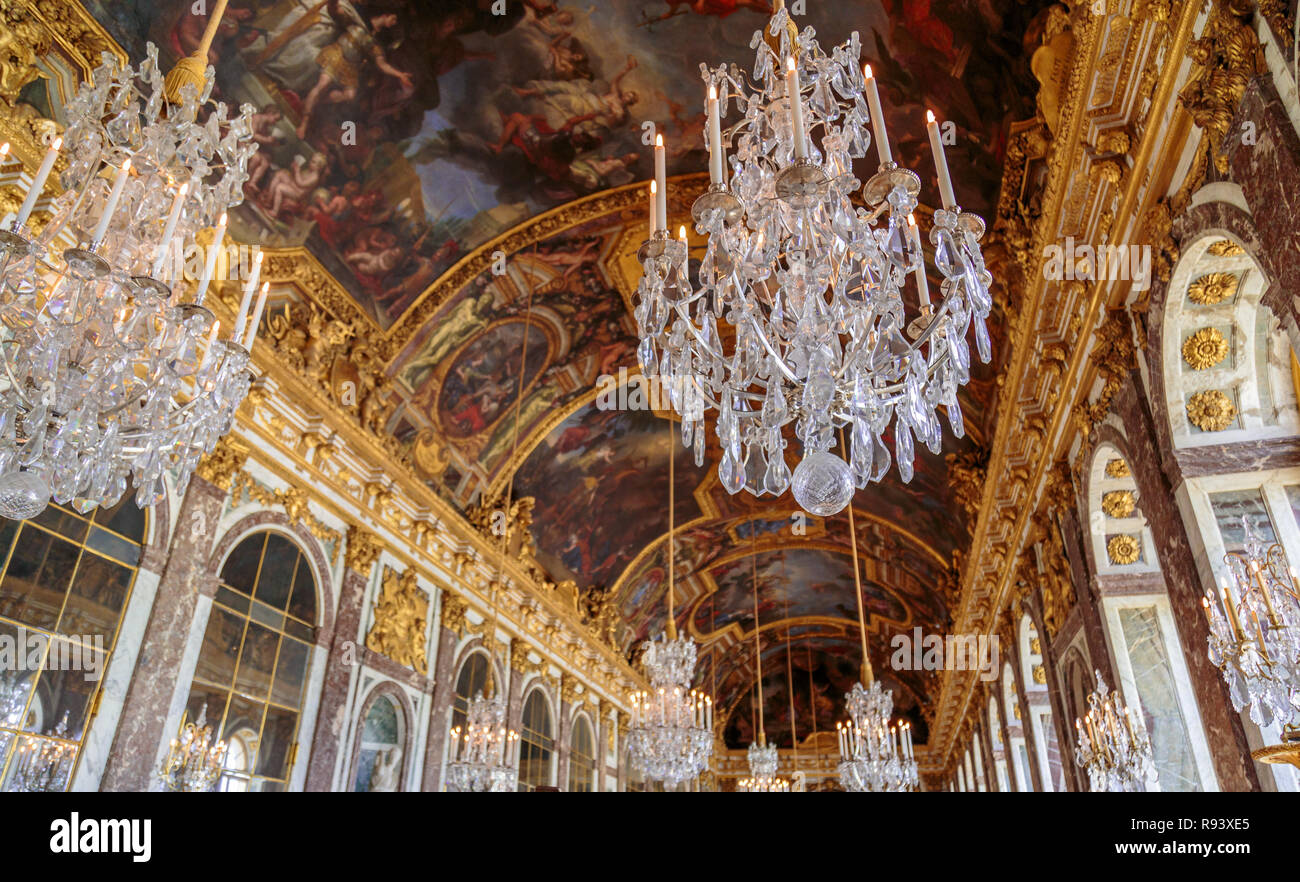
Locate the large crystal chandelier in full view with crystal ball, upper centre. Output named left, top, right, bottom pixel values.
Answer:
left=636, top=1, right=992, bottom=515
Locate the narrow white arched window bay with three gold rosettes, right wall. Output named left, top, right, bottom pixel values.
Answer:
left=1086, top=444, right=1216, bottom=791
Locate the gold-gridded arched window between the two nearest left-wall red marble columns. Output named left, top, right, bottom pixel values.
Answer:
left=187, top=532, right=316, bottom=791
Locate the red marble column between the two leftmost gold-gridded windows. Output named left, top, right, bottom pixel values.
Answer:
left=100, top=473, right=230, bottom=791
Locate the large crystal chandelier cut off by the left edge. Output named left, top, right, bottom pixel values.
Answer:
left=0, top=1, right=267, bottom=519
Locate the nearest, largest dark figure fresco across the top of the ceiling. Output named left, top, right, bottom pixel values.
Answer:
left=87, top=0, right=1047, bottom=328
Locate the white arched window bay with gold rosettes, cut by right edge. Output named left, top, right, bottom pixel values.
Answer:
left=1157, top=234, right=1300, bottom=791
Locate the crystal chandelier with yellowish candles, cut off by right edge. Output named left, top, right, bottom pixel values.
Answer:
left=1201, top=518, right=1300, bottom=740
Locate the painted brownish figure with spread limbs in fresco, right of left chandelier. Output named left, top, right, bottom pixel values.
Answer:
left=298, top=0, right=415, bottom=138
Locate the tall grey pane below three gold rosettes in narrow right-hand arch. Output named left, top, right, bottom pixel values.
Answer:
left=1119, top=606, right=1201, bottom=791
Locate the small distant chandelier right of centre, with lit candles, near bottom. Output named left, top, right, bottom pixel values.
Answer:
left=835, top=679, right=918, bottom=794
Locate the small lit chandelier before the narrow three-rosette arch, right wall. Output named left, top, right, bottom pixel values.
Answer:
left=1074, top=670, right=1156, bottom=792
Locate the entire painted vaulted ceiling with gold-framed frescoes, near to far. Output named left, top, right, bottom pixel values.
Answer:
left=78, top=0, right=1049, bottom=718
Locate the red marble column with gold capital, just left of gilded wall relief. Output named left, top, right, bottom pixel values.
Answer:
left=306, top=527, right=382, bottom=791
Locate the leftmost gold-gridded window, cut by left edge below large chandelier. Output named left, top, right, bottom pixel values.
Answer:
left=0, top=494, right=146, bottom=791
